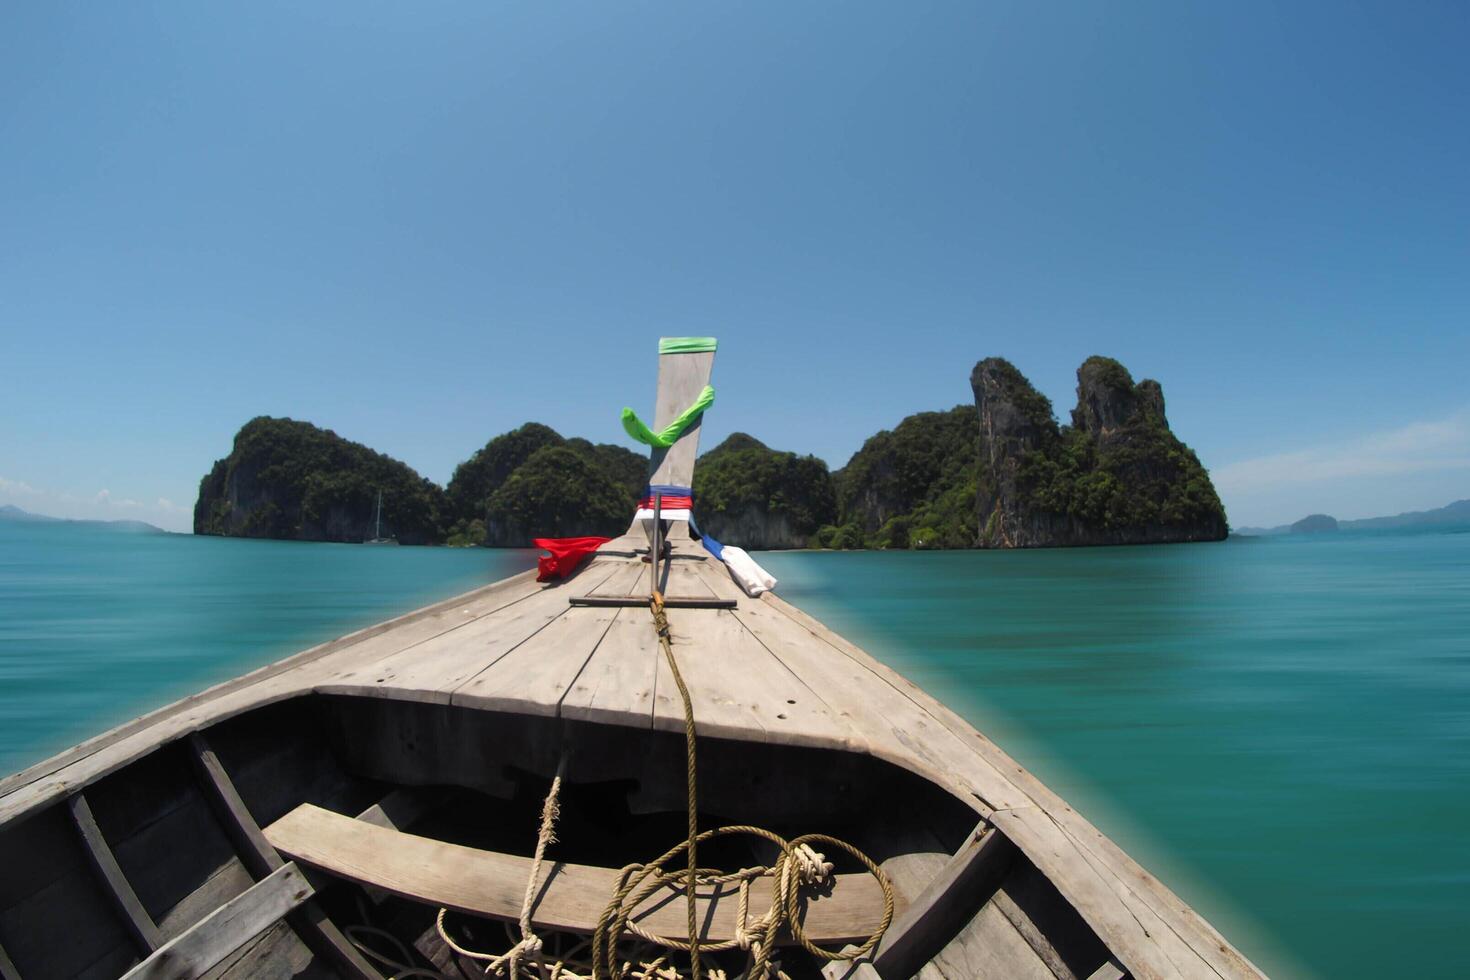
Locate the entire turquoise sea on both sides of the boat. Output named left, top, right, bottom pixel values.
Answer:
left=0, top=523, right=1470, bottom=977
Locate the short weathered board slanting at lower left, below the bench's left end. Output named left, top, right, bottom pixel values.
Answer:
left=122, top=864, right=315, bottom=980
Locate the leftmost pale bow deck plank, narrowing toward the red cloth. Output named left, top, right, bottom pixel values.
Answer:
left=316, top=560, right=623, bottom=704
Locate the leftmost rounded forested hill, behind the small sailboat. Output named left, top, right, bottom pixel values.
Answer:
left=194, top=417, right=444, bottom=544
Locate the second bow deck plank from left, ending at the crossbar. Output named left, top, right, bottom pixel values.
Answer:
left=451, top=599, right=620, bottom=717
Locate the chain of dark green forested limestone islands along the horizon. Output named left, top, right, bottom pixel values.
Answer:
left=194, top=357, right=1227, bottom=550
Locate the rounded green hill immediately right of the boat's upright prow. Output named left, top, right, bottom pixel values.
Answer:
left=694, top=432, right=836, bottom=551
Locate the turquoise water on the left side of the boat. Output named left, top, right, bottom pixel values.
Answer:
left=0, top=520, right=535, bottom=774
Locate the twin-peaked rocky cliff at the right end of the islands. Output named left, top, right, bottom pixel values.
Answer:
left=970, top=357, right=1227, bottom=548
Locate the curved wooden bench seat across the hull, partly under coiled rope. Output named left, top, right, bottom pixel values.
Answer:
left=265, top=804, right=883, bottom=945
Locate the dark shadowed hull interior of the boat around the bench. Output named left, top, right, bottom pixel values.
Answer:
left=0, top=693, right=1108, bottom=980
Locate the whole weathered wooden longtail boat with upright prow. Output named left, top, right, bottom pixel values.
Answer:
left=0, top=344, right=1260, bottom=980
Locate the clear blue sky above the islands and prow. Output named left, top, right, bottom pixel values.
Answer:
left=0, top=1, right=1470, bottom=529
